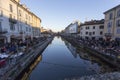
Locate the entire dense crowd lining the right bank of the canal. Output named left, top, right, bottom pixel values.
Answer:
left=62, top=35, right=120, bottom=58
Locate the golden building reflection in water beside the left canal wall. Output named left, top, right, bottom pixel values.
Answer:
left=21, top=55, right=42, bottom=80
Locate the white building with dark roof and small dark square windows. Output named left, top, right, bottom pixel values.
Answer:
left=79, top=19, right=104, bottom=39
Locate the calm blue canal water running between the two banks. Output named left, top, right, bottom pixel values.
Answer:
left=24, top=37, right=114, bottom=80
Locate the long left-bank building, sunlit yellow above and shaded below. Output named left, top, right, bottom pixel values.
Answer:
left=0, top=0, right=41, bottom=43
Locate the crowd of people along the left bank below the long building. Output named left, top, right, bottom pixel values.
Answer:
left=0, top=37, right=46, bottom=57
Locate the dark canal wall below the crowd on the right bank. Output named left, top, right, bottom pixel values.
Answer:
left=62, top=36, right=120, bottom=69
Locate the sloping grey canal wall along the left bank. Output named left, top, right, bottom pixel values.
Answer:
left=0, top=38, right=53, bottom=80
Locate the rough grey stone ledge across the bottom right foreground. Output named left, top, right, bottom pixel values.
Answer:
left=64, top=72, right=120, bottom=80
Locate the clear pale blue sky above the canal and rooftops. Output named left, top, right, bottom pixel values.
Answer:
left=21, top=0, right=120, bottom=32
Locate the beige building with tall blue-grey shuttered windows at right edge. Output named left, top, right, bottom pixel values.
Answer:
left=104, top=5, right=120, bottom=40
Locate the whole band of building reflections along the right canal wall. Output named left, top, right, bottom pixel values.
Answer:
left=63, top=39, right=117, bottom=74
